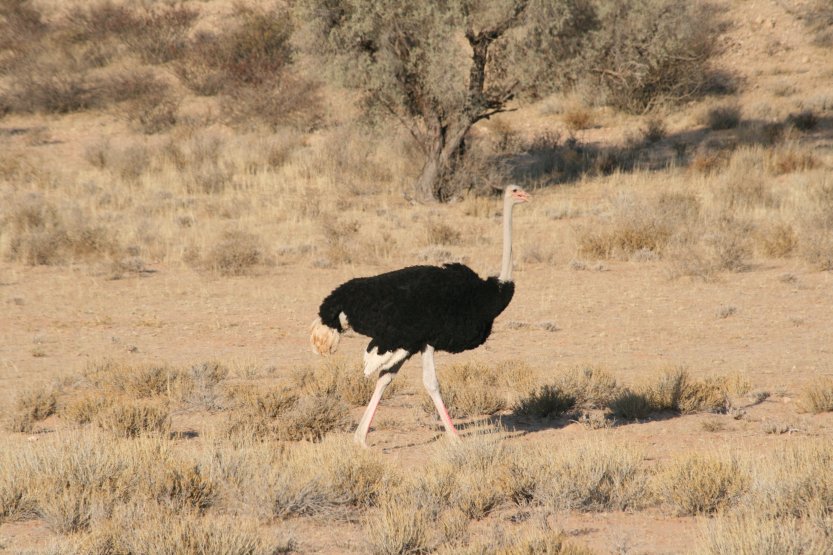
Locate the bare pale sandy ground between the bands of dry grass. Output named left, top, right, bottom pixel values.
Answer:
left=0, top=262, right=833, bottom=553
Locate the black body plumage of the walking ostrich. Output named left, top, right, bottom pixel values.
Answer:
left=318, top=264, right=515, bottom=353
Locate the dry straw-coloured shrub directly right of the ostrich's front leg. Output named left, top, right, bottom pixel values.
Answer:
left=422, top=361, right=532, bottom=418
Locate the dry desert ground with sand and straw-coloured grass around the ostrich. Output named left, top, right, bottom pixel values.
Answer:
left=0, top=0, right=833, bottom=554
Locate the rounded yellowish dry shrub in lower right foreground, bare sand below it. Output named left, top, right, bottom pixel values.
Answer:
left=654, top=453, right=751, bottom=515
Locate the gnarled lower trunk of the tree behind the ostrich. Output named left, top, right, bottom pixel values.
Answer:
left=415, top=120, right=474, bottom=202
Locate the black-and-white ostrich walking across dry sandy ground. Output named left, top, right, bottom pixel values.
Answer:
left=310, top=185, right=529, bottom=446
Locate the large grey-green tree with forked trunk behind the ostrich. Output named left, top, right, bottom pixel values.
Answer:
left=298, top=0, right=598, bottom=201
